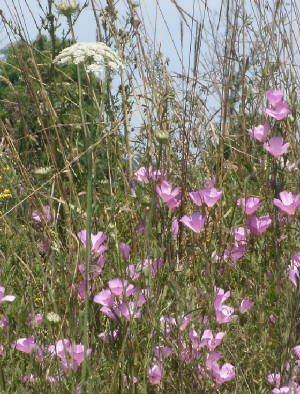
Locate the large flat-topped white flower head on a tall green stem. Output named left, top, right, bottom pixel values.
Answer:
left=53, top=42, right=124, bottom=72
